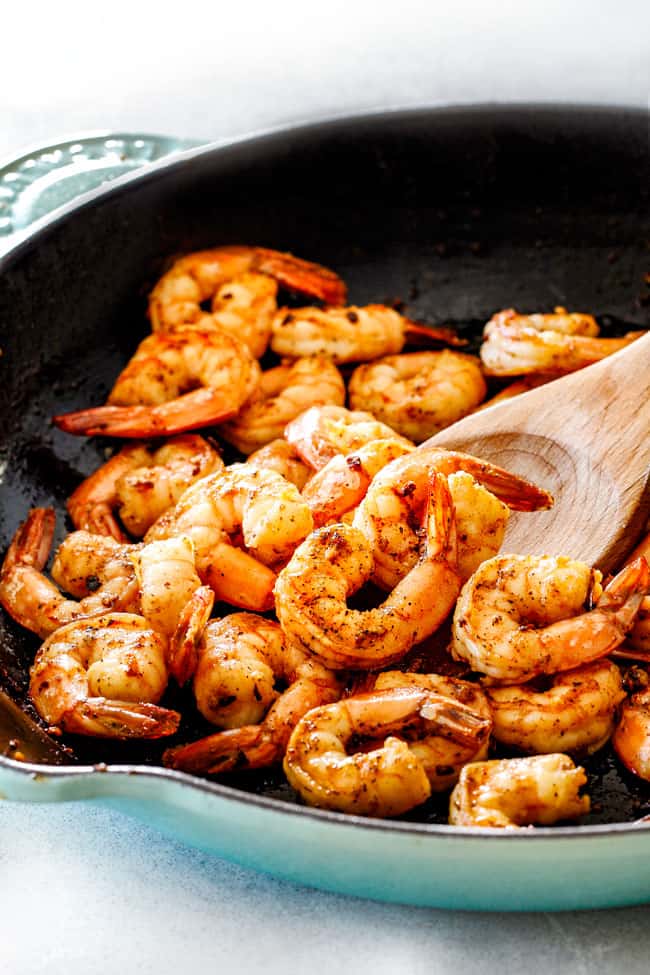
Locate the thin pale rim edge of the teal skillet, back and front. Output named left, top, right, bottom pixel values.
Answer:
left=0, top=101, right=650, bottom=843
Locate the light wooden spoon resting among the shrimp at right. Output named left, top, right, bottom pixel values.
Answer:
left=427, top=334, right=650, bottom=572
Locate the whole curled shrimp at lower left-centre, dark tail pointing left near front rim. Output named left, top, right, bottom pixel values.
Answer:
left=164, top=613, right=341, bottom=774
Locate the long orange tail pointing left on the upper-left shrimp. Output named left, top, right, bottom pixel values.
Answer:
left=52, top=388, right=237, bottom=438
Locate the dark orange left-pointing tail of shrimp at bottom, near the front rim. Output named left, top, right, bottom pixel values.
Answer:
left=163, top=725, right=275, bottom=775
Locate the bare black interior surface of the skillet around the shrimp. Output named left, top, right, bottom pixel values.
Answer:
left=0, top=106, right=650, bottom=822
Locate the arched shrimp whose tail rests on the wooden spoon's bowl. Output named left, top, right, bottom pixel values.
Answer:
left=354, top=446, right=552, bottom=590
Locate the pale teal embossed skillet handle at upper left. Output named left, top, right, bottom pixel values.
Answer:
left=0, top=132, right=201, bottom=252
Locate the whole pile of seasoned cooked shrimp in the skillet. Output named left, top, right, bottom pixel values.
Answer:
left=0, top=246, right=650, bottom=829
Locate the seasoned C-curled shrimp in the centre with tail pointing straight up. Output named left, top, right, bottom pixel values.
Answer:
left=275, top=475, right=460, bottom=670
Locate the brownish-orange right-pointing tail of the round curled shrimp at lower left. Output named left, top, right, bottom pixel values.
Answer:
left=60, top=697, right=181, bottom=739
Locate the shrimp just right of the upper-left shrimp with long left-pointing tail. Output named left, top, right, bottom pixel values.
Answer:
left=219, top=356, right=345, bottom=454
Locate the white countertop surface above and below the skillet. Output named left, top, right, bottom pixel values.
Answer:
left=0, top=0, right=650, bottom=975
